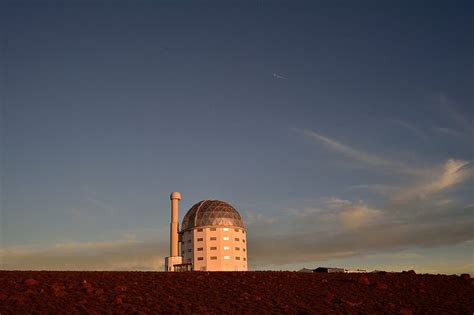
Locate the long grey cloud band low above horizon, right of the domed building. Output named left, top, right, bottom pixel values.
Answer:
left=248, top=211, right=474, bottom=266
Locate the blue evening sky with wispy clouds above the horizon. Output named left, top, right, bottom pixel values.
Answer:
left=0, top=0, right=474, bottom=274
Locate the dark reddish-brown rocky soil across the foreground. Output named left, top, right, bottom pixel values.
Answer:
left=0, top=271, right=474, bottom=315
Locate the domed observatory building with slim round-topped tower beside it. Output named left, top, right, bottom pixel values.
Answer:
left=165, top=192, right=247, bottom=271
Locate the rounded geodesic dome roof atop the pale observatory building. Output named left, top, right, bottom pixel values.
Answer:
left=181, top=200, right=244, bottom=231
